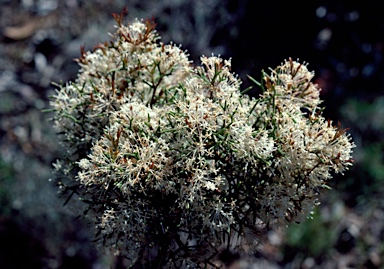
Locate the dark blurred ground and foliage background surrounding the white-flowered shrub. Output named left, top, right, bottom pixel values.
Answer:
left=0, top=0, right=384, bottom=269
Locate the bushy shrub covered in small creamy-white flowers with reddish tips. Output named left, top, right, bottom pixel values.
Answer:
left=52, top=11, right=354, bottom=268
